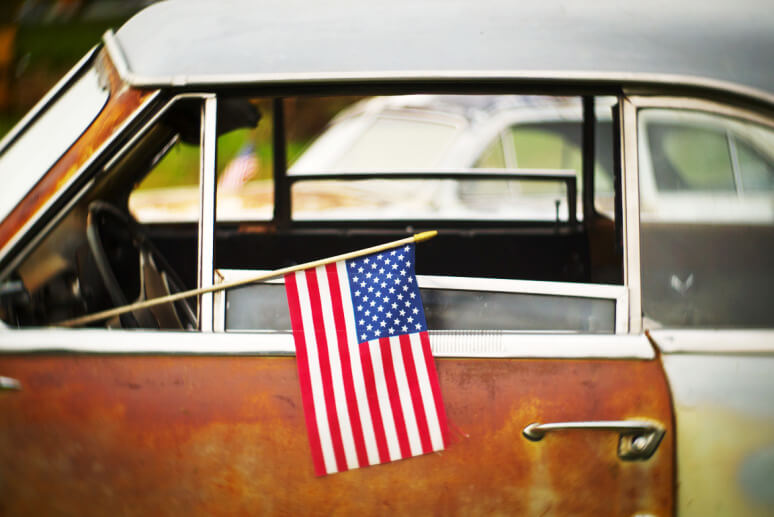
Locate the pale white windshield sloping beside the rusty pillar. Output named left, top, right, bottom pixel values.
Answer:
left=0, top=64, right=110, bottom=219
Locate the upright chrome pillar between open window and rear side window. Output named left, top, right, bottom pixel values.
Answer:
left=620, top=97, right=642, bottom=334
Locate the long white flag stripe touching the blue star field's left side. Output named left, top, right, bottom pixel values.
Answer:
left=336, top=260, right=379, bottom=465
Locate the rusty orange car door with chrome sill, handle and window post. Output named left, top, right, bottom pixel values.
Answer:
left=0, top=91, right=675, bottom=515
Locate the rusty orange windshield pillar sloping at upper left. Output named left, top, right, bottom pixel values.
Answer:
left=0, top=50, right=152, bottom=248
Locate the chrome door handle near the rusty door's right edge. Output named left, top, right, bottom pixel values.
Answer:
left=522, top=420, right=666, bottom=461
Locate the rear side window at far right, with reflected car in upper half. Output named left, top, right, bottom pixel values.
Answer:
left=638, top=108, right=774, bottom=328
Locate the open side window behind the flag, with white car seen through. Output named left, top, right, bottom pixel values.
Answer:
left=213, top=95, right=628, bottom=333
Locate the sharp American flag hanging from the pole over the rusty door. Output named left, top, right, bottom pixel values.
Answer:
left=285, top=244, right=448, bottom=476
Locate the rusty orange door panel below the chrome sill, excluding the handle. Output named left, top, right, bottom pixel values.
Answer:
left=0, top=355, right=674, bottom=516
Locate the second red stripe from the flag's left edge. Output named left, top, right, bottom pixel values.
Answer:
left=304, top=269, right=347, bottom=472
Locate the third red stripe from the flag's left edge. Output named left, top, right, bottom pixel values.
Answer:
left=325, top=264, right=368, bottom=467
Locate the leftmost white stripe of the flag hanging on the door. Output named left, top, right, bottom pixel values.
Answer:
left=296, top=271, right=338, bottom=474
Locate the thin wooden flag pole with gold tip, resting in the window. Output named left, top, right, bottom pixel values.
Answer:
left=54, top=230, right=438, bottom=327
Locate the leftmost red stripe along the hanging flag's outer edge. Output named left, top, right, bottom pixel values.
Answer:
left=285, top=273, right=326, bottom=476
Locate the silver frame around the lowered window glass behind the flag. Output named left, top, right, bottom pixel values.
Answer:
left=215, top=269, right=629, bottom=334
